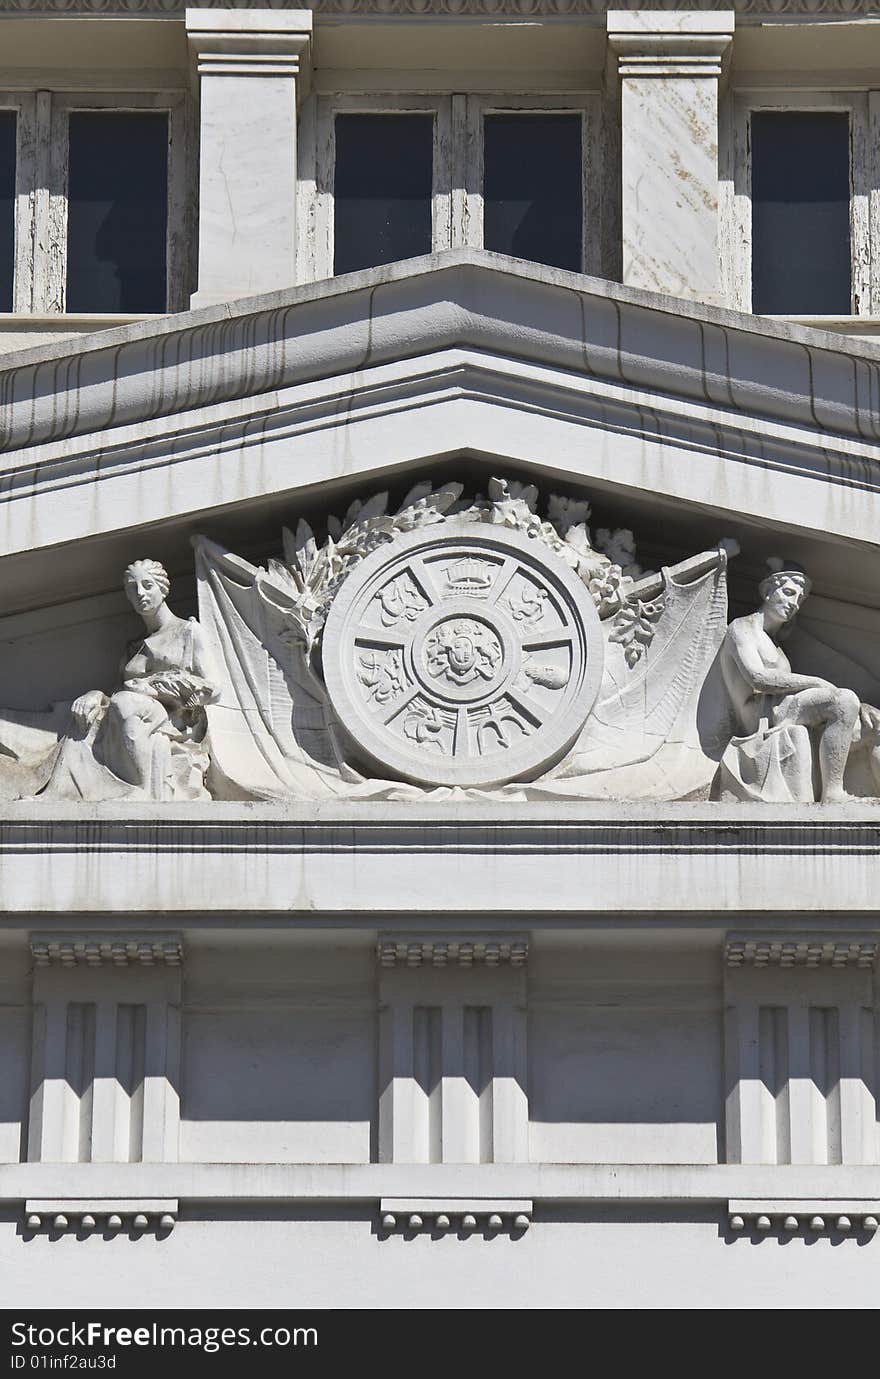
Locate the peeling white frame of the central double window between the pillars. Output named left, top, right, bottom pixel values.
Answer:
left=297, top=91, right=617, bottom=283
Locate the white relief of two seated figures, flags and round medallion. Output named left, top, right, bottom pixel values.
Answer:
left=0, top=479, right=880, bottom=804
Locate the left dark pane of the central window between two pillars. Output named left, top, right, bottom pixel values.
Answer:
left=334, top=114, right=434, bottom=273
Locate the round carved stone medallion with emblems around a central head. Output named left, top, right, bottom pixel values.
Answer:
left=323, top=519, right=603, bottom=786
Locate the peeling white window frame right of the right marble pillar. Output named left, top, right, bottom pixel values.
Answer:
left=721, top=90, right=880, bottom=320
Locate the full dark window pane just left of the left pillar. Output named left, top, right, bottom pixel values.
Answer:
left=68, top=110, right=168, bottom=313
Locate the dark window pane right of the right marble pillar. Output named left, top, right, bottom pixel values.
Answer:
left=752, top=112, right=852, bottom=316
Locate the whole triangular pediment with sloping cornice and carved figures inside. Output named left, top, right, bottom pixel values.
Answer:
left=0, top=252, right=880, bottom=803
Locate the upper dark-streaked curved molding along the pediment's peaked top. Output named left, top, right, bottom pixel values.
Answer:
left=0, top=250, right=879, bottom=457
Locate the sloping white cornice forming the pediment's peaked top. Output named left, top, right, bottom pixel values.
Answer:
left=0, top=251, right=880, bottom=610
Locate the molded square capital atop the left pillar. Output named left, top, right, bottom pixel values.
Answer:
left=186, top=10, right=313, bottom=84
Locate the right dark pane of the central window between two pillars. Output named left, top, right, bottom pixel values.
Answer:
left=483, top=114, right=583, bottom=273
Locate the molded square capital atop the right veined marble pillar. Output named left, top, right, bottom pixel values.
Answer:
left=607, top=10, right=737, bottom=77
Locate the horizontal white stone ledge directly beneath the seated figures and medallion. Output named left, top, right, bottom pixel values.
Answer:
left=0, top=801, right=880, bottom=915
